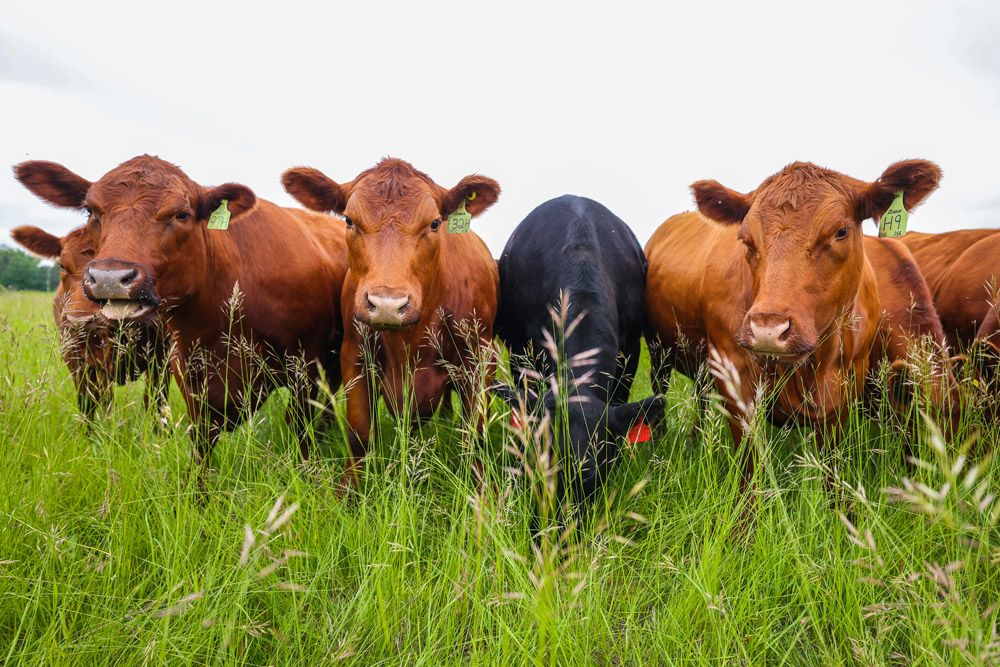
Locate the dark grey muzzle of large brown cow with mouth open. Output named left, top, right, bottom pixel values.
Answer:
left=83, top=260, right=159, bottom=320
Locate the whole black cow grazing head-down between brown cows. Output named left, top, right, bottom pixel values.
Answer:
left=493, top=195, right=666, bottom=501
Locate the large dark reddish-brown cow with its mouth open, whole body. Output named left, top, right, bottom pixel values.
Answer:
left=15, top=155, right=347, bottom=474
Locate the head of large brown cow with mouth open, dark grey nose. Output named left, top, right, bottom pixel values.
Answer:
left=14, top=155, right=256, bottom=320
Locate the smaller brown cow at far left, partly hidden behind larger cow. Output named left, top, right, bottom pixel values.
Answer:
left=11, top=226, right=170, bottom=420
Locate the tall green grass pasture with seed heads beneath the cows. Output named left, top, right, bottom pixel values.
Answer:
left=0, top=292, right=1000, bottom=665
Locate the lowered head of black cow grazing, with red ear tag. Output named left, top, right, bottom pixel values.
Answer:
left=491, top=383, right=667, bottom=500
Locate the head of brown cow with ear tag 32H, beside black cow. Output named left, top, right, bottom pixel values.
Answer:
left=281, top=158, right=500, bottom=329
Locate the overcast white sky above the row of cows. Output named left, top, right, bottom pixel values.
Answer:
left=0, top=0, right=1000, bottom=255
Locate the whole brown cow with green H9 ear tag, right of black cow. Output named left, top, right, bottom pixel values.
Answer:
left=646, top=160, right=956, bottom=512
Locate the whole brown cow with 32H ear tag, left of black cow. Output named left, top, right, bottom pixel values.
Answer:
left=282, top=158, right=500, bottom=484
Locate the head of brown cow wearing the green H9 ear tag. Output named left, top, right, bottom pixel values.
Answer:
left=691, top=160, right=941, bottom=363
